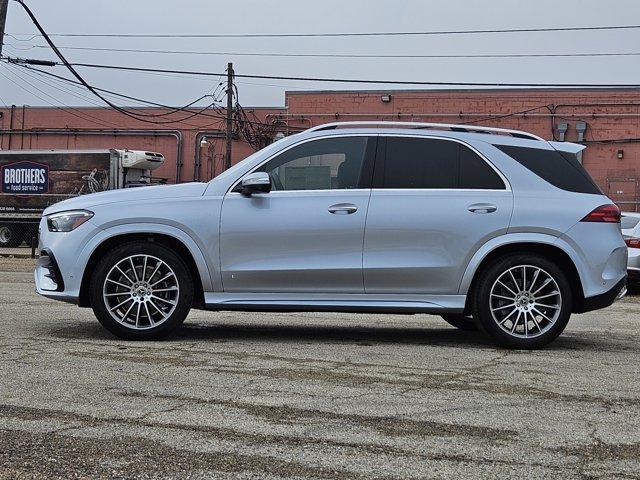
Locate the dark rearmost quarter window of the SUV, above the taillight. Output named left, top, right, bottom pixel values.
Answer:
left=494, top=145, right=602, bottom=194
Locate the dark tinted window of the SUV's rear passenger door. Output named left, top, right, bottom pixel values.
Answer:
left=376, top=137, right=505, bottom=190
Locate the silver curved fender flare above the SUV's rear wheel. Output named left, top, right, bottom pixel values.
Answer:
left=458, top=233, right=588, bottom=295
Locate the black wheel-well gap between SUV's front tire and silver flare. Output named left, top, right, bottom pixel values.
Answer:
left=78, top=231, right=209, bottom=308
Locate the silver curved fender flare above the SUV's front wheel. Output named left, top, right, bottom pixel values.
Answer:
left=74, top=221, right=221, bottom=292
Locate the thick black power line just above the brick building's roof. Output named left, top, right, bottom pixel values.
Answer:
left=46, top=59, right=640, bottom=88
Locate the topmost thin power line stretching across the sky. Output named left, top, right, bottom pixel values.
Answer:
left=6, top=25, right=640, bottom=41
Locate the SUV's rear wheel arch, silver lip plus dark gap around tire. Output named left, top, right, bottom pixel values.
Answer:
left=460, top=237, right=585, bottom=313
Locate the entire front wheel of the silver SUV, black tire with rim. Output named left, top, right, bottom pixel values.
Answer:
left=89, top=242, right=194, bottom=340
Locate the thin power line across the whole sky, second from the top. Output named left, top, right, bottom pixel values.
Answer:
left=5, top=44, right=640, bottom=59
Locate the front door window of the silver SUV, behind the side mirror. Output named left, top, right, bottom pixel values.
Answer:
left=259, top=137, right=368, bottom=190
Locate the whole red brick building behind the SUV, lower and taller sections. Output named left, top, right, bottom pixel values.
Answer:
left=0, top=89, right=640, bottom=209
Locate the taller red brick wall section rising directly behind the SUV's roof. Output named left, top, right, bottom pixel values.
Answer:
left=283, top=90, right=640, bottom=208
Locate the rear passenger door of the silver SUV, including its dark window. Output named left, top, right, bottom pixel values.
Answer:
left=363, top=135, right=513, bottom=294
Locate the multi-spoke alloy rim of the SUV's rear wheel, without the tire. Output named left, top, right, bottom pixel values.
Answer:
left=489, top=265, right=562, bottom=338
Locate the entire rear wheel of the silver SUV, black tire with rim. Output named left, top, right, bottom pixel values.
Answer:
left=473, top=254, right=573, bottom=349
